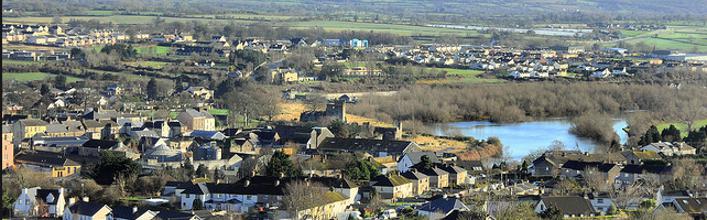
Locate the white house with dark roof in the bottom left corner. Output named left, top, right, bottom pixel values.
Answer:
left=12, top=187, right=66, bottom=218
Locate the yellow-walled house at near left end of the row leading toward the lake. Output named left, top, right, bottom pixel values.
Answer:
left=371, top=175, right=414, bottom=200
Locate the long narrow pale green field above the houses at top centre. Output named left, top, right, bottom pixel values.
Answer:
left=283, top=21, right=481, bottom=37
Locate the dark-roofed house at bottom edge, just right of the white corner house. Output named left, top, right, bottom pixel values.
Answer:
left=63, top=198, right=113, bottom=220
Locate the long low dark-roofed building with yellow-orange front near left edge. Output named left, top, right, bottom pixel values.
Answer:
left=15, top=151, right=81, bottom=177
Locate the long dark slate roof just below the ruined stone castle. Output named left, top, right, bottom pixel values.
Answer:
left=319, top=138, right=418, bottom=155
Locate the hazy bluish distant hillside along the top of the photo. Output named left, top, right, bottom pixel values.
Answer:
left=3, top=0, right=707, bottom=23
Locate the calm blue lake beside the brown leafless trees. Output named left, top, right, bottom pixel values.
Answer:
left=434, top=119, right=628, bottom=159
